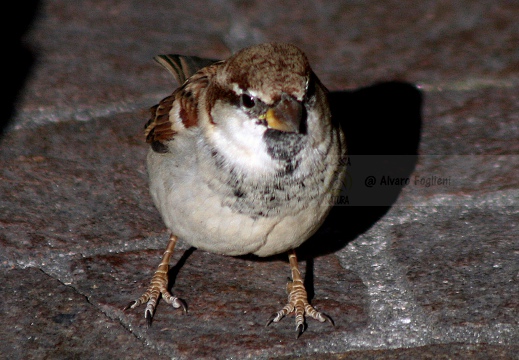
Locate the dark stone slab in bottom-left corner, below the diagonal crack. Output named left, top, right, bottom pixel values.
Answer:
left=0, top=268, right=166, bottom=359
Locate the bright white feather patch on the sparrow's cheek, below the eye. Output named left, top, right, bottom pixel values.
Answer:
left=209, top=102, right=274, bottom=173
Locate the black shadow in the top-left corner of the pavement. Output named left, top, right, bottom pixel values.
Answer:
left=0, top=0, right=40, bottom=140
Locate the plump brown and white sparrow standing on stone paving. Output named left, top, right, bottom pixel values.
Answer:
left=125, top=43, right=346, bottom=337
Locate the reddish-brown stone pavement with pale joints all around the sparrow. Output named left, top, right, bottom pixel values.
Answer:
left=0, top=0, right=519, bottom=359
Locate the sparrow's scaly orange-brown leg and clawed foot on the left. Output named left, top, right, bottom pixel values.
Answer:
left=124, top=235, right=187, bottom=327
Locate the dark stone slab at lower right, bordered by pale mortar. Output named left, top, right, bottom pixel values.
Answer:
left=391, top=205, right=519, bottom=327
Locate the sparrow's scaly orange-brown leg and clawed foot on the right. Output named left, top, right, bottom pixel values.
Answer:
left=266, top=250, right=335, bottom=338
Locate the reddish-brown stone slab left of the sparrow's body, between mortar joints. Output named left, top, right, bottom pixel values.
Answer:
left=0, top=114, right=163, bottom=262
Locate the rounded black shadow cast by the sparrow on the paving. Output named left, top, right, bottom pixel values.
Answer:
left=298, top=82, right=422, bottom=259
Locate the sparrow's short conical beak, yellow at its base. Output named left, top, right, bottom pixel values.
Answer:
left=264, top=96, right=303, bottom=133
